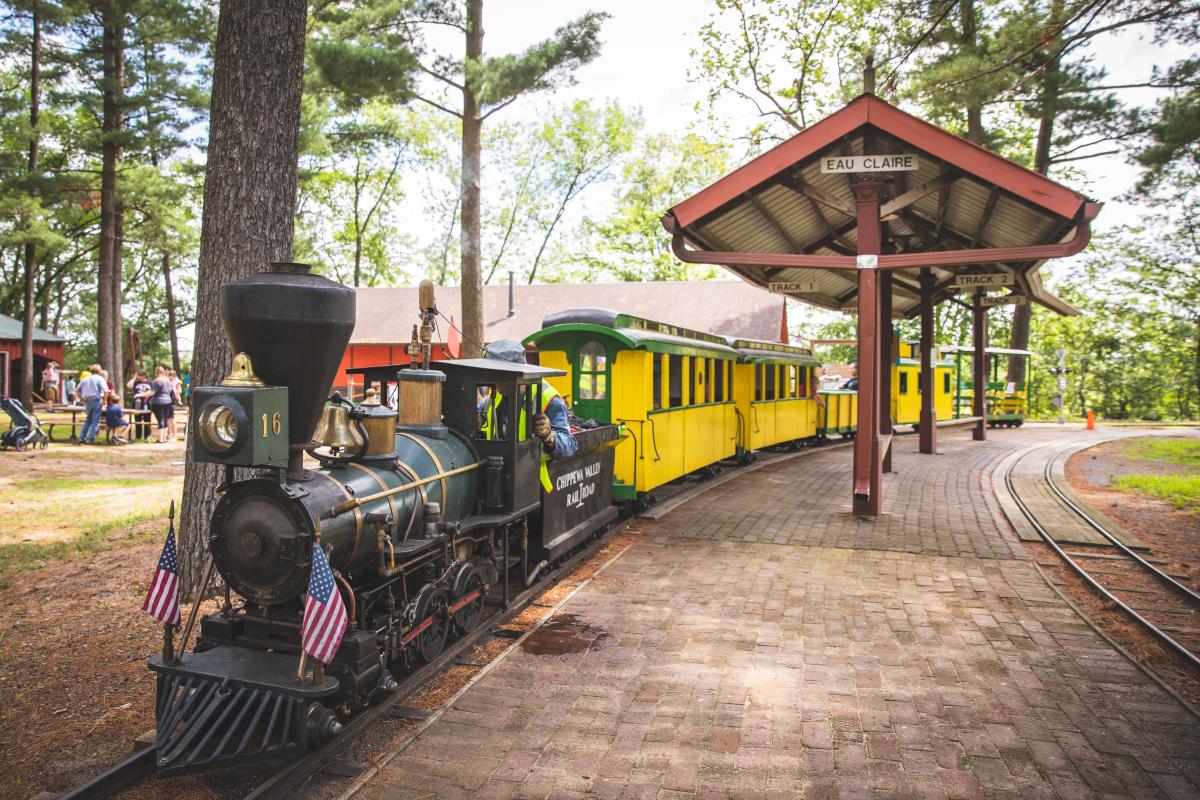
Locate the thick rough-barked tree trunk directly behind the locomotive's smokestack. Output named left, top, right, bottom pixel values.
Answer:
left=179, top=0, right=307, bottom=597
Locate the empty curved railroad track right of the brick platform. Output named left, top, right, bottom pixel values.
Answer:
left=1004, top=445, right=1200, bottom=672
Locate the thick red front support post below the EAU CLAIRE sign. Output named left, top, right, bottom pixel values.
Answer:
left=852, top=180, right=883, bottom=517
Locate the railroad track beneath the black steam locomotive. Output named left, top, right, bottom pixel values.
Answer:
left=49, top=517, right=636, bottom=800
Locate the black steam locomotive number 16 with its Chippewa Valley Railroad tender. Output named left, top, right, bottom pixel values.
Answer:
left=149, top=264, right=620, bottom=772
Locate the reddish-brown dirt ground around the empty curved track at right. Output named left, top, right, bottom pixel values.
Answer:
left=1056, top=438, right=1200, bottom=706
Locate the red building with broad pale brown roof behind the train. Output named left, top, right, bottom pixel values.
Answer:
left=335, top=281, right=787, bottom=390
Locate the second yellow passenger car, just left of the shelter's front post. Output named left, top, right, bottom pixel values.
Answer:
left=730, top=339, right=821, bottom=459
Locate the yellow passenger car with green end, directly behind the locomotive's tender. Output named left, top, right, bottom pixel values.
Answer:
left=526, top=308, right=738, bottom=501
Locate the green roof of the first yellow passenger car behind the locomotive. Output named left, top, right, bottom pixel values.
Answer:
left=524, top=308, right=738, bottom=357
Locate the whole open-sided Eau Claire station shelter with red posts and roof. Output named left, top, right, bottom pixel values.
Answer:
left=662, top=66, right=1100, bottom=516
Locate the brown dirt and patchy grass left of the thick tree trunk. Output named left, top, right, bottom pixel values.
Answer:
left=0, top=444, right=189, bottom=798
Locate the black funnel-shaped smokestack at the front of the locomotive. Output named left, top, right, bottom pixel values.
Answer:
left=221, top=261, right=355, bottom=475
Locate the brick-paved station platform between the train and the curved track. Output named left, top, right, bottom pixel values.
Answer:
left=340, top=427, right=1200, bottom=800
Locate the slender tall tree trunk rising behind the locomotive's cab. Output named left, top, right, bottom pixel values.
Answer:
left=458, top=0, right=485, bottom=359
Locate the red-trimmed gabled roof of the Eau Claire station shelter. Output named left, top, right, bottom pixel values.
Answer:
left=662, top=95, right=1099, bottom=315
